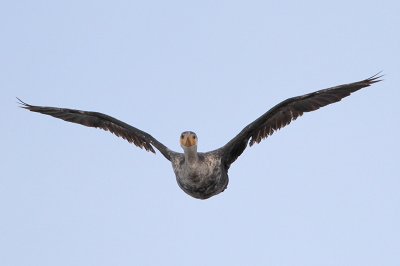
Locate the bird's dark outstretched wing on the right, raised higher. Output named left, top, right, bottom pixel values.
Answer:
left=218, top=73, right=382, bottom=167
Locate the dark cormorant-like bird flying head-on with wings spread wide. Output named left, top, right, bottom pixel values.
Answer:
left=17, top=72, right=383, bottom=200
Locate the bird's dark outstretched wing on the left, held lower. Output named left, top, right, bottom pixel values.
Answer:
left=17, top=98, right=172, bottom=160
